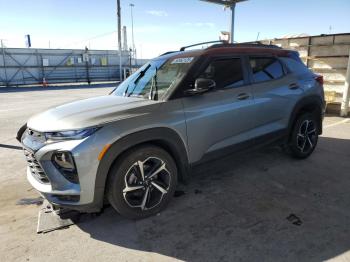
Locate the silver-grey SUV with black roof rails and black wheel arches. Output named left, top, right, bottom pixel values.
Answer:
left=18, top=44, right=325, bottom=219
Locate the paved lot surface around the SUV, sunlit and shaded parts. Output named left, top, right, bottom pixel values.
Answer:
left=0, top=87, right=350, bottom=261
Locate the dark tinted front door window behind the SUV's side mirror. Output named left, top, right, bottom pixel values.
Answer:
left=199, top=58, right=244, bottom=88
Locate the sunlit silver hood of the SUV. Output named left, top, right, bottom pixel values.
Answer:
left=27, top=95, right=160, bottom=132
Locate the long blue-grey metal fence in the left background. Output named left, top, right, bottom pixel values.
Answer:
left=0, top=48, right=134, bottom=86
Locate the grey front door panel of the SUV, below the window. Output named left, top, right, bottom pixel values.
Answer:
left=183, top=86, right=254, bottom=162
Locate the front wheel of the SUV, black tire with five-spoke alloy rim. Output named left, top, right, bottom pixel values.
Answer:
left=107, top=145, right=177, bottom=219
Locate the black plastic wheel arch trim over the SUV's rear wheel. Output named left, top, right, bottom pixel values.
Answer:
left=287, top=95, right=325, bottom=139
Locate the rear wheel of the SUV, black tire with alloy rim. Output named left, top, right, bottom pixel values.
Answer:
left=287, top=113, right=319, bottom=159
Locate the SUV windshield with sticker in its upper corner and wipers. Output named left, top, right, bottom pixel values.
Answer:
left=112, top=57, right=194, bottom=100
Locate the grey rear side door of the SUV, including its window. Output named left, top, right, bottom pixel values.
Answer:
left=247, top=57, right=303, bottom=138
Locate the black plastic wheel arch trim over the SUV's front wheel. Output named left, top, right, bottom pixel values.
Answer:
left=93, top=127, right=189, bottom=210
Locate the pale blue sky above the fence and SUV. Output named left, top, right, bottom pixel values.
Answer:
left=0, top=0, right=350, bottom=58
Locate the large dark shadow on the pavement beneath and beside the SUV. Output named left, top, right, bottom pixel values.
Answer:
left=78, top=137, right=350, bottom=261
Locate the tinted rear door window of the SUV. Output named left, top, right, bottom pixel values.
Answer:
left=249, top=57, right=284, bottom=83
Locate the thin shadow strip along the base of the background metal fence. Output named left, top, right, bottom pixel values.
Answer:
left=0, top=83, right=117, bottom=94
